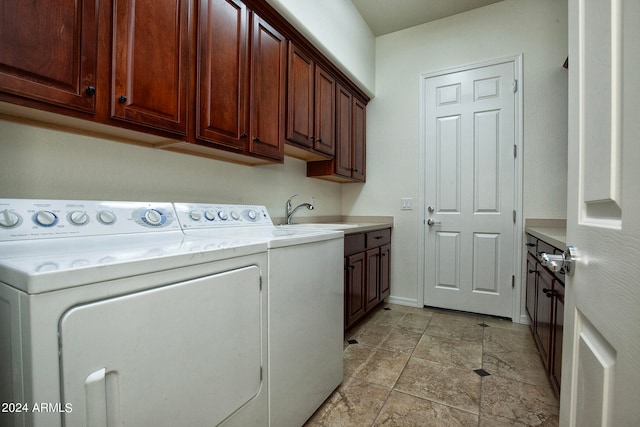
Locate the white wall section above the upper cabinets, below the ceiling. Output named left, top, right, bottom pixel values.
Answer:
left=267, top=0, right=375, bottom=96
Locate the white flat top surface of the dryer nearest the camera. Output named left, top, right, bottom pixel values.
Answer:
left=0, top=236, right=267, bottom=294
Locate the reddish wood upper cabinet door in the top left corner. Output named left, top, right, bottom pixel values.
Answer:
left=0, top=0, right=98, bottom=113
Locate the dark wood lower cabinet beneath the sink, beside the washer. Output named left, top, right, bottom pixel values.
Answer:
left=344, top=228, right=391, bottom=330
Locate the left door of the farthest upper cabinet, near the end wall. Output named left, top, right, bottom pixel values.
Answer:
left=335, top=84, right=353, bottom=178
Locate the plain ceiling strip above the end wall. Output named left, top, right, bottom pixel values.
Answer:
left=351, top=0, right=502, bottom=37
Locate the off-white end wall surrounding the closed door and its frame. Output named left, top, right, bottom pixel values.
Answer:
left=342, top=0, right=567, bottom=303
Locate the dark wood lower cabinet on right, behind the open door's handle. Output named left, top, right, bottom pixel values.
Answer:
left=525, top=235, right=564, bottom=396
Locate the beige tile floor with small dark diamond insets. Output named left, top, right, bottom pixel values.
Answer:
left=305, top=304, right=558, bottom=427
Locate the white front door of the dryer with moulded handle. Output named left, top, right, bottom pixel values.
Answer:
left=60, top=266, right=266, bottom=427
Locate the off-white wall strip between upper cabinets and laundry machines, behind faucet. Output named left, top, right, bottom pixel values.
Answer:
left=0, top=120, right=341, bottom=217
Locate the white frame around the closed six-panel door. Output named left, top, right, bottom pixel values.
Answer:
left=416, top=53, right=529, bottom=323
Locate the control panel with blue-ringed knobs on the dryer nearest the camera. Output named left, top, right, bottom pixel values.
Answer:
left=0, top=199, right=181, bottom=241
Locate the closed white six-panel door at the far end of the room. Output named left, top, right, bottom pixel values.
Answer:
left=422, top=62, right=515, bottom=317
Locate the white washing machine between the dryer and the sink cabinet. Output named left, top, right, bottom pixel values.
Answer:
left=174, top=203, right=344, bottom=427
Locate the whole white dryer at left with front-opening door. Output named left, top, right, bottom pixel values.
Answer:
left=0, top=199, right=268, bottom=427
